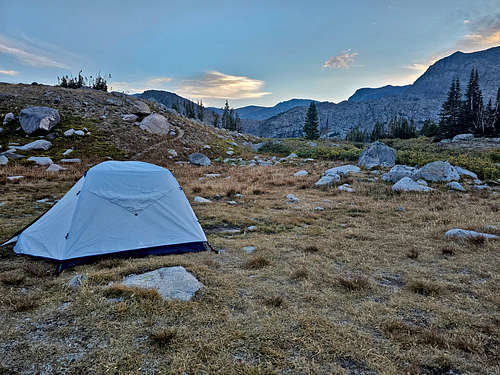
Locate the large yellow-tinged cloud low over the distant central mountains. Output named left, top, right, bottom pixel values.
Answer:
left=178, top=71, right=271, bottom=99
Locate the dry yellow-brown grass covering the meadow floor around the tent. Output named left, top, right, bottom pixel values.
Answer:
left=0, top=157, right=500, bottom=374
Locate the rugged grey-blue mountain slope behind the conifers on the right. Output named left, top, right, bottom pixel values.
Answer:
left=250, top=47, right=500, bottom=137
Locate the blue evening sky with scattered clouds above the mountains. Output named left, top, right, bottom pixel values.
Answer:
left=0, top=0, right=500, bottom=107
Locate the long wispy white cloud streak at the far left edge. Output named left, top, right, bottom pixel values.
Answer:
left=0, top=35, right=69, bottom=69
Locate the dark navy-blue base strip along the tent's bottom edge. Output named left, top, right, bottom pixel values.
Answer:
left=53, top=241, right=209, bottom=274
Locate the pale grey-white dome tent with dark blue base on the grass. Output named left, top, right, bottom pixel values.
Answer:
left=7, top=161, right=207, bottom=271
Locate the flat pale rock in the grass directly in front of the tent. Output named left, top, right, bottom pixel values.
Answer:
left=122, top=266, right=203, bottom=301
